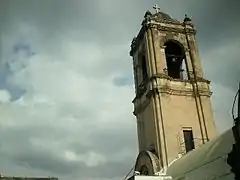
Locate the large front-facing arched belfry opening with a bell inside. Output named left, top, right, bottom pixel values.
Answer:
left=164, top=41, right=188, bottom=79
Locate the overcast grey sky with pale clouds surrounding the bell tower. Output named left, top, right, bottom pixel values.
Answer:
left=0, top=0, right=240, bottom=180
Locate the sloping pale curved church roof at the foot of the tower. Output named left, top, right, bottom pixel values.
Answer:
left=167, top=129, right=235, bottom=180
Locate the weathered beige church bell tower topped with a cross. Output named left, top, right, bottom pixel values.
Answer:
left=130, top=6, right=217, bottom=174
